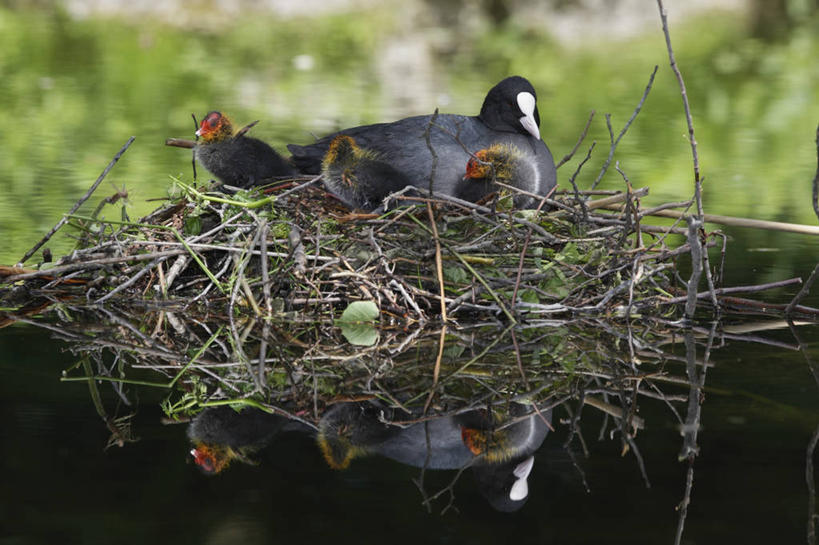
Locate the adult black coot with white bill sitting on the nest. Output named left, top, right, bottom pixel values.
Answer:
left=288, top=76, right=556, bottom=203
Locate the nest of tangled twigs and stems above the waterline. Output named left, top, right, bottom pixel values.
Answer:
left=0, top=180, right=686, bottom=322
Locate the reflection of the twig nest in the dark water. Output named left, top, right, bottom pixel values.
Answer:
left=32, top=306, right=712, bottom=462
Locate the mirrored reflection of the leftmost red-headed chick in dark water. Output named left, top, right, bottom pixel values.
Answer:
left=188, top=407, right=312, bottom=475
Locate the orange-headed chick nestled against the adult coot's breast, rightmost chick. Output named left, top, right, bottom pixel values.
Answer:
left=458, top=144, right=545, bottom=208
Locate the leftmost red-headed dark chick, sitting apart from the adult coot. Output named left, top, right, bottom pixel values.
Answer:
left=194, top=111, right=295, bottom=187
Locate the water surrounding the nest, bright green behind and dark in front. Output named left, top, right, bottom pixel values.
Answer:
left=0, top=5, right=819, bottom=544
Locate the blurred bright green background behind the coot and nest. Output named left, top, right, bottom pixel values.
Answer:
left=0, top=0, right=819, bottom=272
